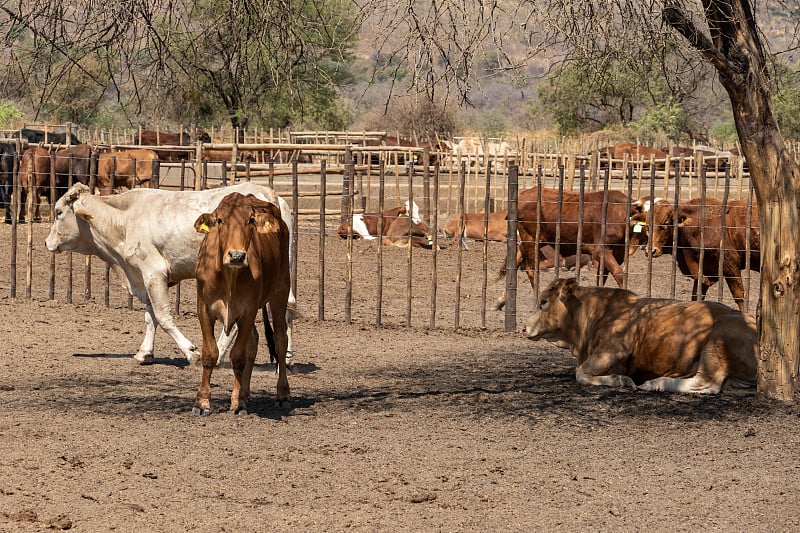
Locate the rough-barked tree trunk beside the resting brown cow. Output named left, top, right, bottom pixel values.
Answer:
left=664, top=0, right=800, bottom=401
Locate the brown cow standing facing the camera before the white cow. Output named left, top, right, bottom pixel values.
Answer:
left=192, top=193, right=291, bottom=416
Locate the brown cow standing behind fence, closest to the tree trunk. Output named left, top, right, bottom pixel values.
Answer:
left=631, top=198, right=761, bottom=312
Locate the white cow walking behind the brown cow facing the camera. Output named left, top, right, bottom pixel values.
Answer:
left=45, top=183, right=294, bottom=363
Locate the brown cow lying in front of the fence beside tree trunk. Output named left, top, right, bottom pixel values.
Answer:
left=525, top=278, right=758, bottom=394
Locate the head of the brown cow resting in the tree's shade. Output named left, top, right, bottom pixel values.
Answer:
left=525, top=278, right=578, bottom=346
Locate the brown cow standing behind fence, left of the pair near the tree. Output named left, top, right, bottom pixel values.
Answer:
left=496, top=187, right=643, bottom=309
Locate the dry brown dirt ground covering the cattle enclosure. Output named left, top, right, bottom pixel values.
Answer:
left=0, top=218, right=800, bottom=532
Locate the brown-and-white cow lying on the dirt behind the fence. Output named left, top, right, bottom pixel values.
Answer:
left=336, top=201, right=433, bottom=249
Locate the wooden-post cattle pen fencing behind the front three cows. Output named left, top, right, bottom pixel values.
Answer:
left=0, top=131, right=758, bottom=336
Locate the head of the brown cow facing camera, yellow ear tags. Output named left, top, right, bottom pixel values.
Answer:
left=194, top=193, right=284, bottom=269
